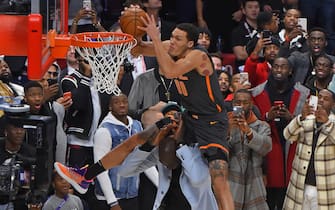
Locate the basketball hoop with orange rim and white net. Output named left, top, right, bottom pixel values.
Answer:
left=71, top=32, right=136, bottom=95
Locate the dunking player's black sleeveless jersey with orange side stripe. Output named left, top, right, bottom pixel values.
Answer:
left=175, top=48, right=223, bottom=115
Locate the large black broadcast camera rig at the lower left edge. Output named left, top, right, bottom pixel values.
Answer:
left=0, top=100, right=56, bottom=203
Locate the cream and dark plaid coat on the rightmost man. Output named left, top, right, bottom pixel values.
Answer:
left=283, top=114, right=335, bottom=210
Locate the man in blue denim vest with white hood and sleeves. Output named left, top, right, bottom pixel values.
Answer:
left=94, top=94, right=158, bottom=210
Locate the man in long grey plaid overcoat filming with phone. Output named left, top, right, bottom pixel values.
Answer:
left=228, top=89, right=272, bottom=210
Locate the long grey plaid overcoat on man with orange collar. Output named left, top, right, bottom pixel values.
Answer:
left=228, top=112, right=272, bottom=210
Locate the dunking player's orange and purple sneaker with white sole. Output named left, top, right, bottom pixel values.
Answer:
left=54, top=162, right=93, bottom=194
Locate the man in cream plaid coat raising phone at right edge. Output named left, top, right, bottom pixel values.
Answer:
left=283, top=88, right=335, bottom=210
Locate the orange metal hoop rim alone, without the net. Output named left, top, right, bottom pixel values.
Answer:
left=71, top=32, right=134, bottom=48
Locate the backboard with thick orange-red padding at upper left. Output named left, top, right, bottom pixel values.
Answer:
left=0, top=0, right=70, bottom=80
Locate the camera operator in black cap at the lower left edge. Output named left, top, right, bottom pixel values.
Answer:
left=0, top=114, right=36, bottom=210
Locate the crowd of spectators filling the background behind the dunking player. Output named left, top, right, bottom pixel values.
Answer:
left=0, top=0, right=335, bottom=210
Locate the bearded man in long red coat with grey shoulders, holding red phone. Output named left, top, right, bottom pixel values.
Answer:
left=252, top=57, right=309, bottom=209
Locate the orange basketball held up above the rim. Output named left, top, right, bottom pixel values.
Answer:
left=120, top=7, right=146, bottom=37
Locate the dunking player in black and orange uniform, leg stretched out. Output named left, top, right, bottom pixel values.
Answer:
left=55, top=6, right=234, bottom=210
